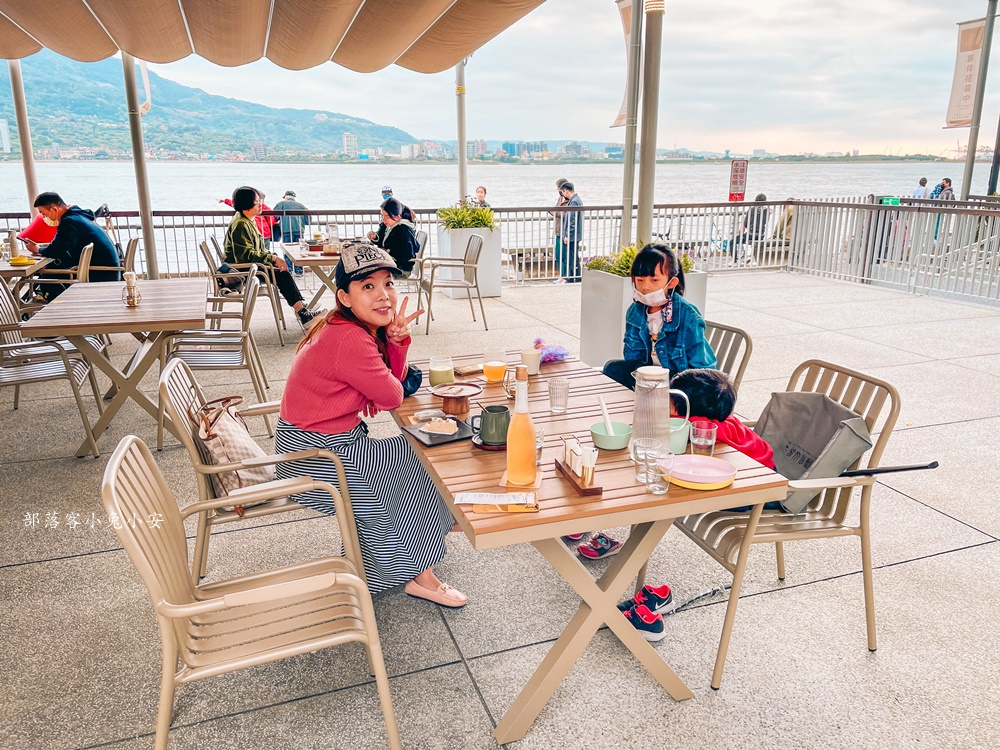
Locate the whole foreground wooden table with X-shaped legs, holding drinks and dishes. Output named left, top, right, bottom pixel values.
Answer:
left=393, top=352, right=788, bottom=744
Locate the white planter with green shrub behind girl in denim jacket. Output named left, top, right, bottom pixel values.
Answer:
left=580, top=245, right=708, bottom=367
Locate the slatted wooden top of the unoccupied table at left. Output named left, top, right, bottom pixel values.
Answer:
left=21, top=278, right=208, bottom=336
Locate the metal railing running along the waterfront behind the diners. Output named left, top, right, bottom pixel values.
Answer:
left=7, top=196, right=1000, bottom=303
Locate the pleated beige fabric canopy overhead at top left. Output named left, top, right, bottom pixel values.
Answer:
left=0, top=0, right=545, bottom=73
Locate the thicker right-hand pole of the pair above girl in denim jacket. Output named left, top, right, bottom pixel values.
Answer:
left=636, top=0, right=665, bottom=242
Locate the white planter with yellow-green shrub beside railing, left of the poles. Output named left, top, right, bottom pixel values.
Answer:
left=437, top=206, right=502, bottom=299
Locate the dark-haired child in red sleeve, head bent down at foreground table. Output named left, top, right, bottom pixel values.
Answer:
left=670, top=370, right=774, bottom=469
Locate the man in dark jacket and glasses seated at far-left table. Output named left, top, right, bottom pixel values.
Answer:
left=26, top=192, right=121, bottom=300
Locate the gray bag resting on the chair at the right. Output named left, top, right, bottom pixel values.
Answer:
left=755, top=391, right=872, bottom=513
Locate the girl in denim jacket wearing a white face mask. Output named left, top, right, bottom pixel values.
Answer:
left=604, top=243, right=716, bottom=390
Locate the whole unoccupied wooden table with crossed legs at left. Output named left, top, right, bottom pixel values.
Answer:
left=21, top=278, right=208, bottom=456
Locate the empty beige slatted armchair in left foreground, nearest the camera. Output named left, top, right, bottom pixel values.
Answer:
left=101, top=435, right=402, bottom=750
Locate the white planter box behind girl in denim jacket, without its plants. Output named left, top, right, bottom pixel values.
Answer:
left=580, top=268, right=708, bottom=367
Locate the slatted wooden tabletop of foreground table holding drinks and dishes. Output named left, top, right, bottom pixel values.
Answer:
left=393, top=352, right=788, bottom=549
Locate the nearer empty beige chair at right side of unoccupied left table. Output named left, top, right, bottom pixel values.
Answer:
left=156, top=264, right=274, bottom=448
